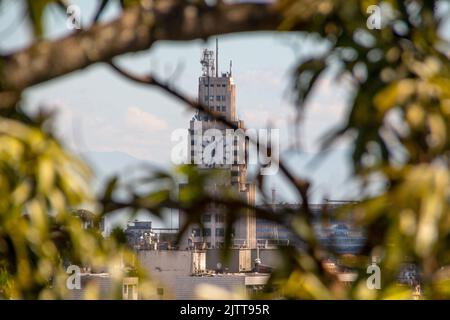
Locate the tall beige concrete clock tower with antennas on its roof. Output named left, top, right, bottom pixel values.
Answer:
left=180, top=42, right=256, bottom=248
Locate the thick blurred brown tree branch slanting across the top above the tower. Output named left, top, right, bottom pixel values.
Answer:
left=0, top=0, right=282, bottom=106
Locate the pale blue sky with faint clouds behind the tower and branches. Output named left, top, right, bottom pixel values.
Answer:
left=6, top=0, right=442, bottom=229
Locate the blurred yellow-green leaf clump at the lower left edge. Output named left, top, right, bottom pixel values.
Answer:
left=0, top=111, right=134, bottom=299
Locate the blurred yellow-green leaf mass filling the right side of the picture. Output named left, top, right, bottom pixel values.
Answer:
left=281, top=0, right=450, bottom=298
